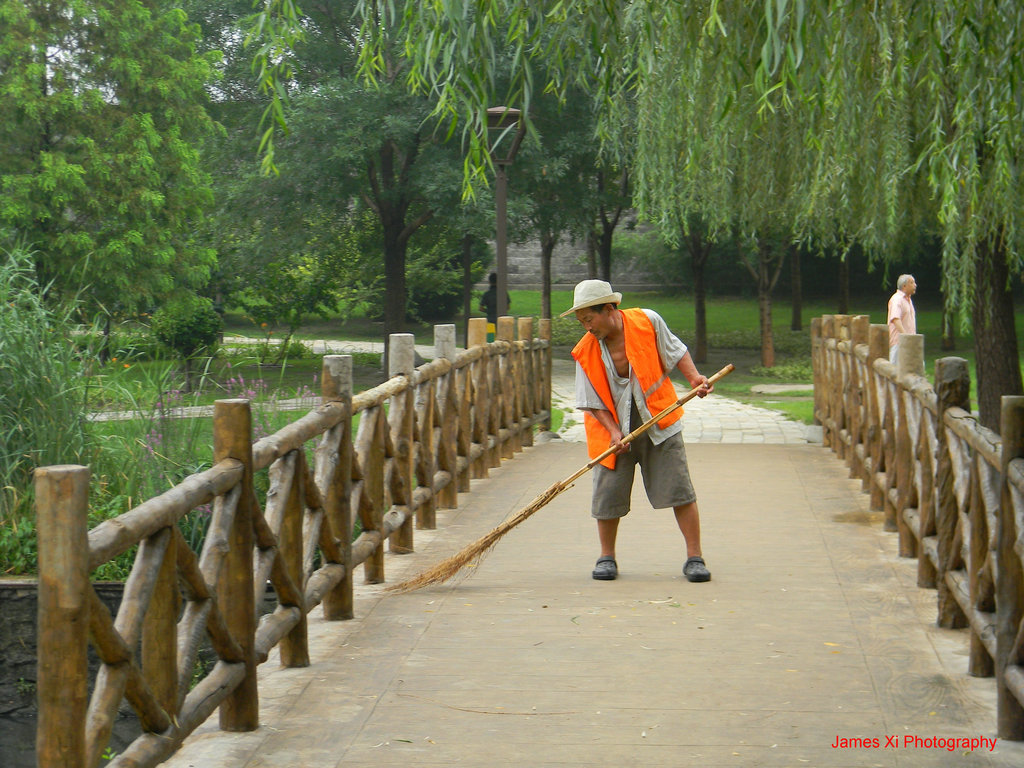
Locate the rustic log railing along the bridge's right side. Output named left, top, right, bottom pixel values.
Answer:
left=811, top=315, right=1024, bottom=740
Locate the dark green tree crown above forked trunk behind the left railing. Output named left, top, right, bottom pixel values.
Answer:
left=237, top=0, right=493, bottom=342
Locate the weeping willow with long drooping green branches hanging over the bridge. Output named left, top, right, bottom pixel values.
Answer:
left=253, top=0, right=1024, bottom=425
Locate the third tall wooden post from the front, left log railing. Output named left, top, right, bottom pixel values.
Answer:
left=316, top=354, right=355, bottom=622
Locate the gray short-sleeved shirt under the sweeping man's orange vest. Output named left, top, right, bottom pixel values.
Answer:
left=575, top=309, right=686, bottom=445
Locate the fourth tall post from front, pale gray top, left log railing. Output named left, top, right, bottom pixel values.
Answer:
left=388, top=334, right=416, bottom=555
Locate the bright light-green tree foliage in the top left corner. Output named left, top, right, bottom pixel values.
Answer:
left=0, top=0, right=217, bottom=315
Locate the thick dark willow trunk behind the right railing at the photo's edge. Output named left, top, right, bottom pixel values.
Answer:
left=972, top=239, right=1024, bottom=431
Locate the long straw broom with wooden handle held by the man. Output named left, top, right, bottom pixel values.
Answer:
left=385, top=362, right=734, bottom=592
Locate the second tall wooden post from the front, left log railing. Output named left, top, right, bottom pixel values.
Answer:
left=213, top=399, right=259, bottom=731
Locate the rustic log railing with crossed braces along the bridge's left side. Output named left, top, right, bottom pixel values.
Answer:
left=36, top=317, right=551, bottom=768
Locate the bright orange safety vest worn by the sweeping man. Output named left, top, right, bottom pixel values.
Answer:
left=572, top=308, right=683, bottom=469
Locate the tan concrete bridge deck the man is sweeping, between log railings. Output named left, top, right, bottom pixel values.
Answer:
left=166, top=434, right=1024, bottom=768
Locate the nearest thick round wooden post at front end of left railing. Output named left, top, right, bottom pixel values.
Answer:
left=35, top=465, right=92, bottom=768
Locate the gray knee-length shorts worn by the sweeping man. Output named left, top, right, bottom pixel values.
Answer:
left=590, top=434, right=697, bottom=520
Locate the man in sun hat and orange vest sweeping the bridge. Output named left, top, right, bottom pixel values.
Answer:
left=561, top=280, right=714, bottom=582
